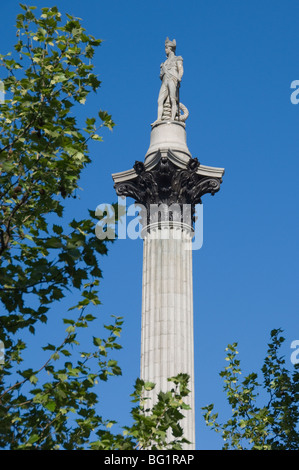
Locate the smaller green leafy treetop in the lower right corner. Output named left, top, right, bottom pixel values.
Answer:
left=203, top=329, right=299, bottom=450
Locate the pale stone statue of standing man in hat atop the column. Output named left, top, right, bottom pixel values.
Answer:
left=157, top=38, right=184, bottom=121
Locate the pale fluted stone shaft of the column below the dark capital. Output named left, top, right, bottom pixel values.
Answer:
left=140, top=222, right=195, bottom=449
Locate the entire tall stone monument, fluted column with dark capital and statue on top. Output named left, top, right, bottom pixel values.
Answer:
left=112, top=38, right=224, bottom=450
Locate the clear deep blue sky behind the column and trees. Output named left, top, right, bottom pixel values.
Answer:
left=0, top=0, right=299, bottom=449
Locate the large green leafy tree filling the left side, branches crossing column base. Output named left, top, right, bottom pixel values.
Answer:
left=0, top=5, right=188, bottom=449
